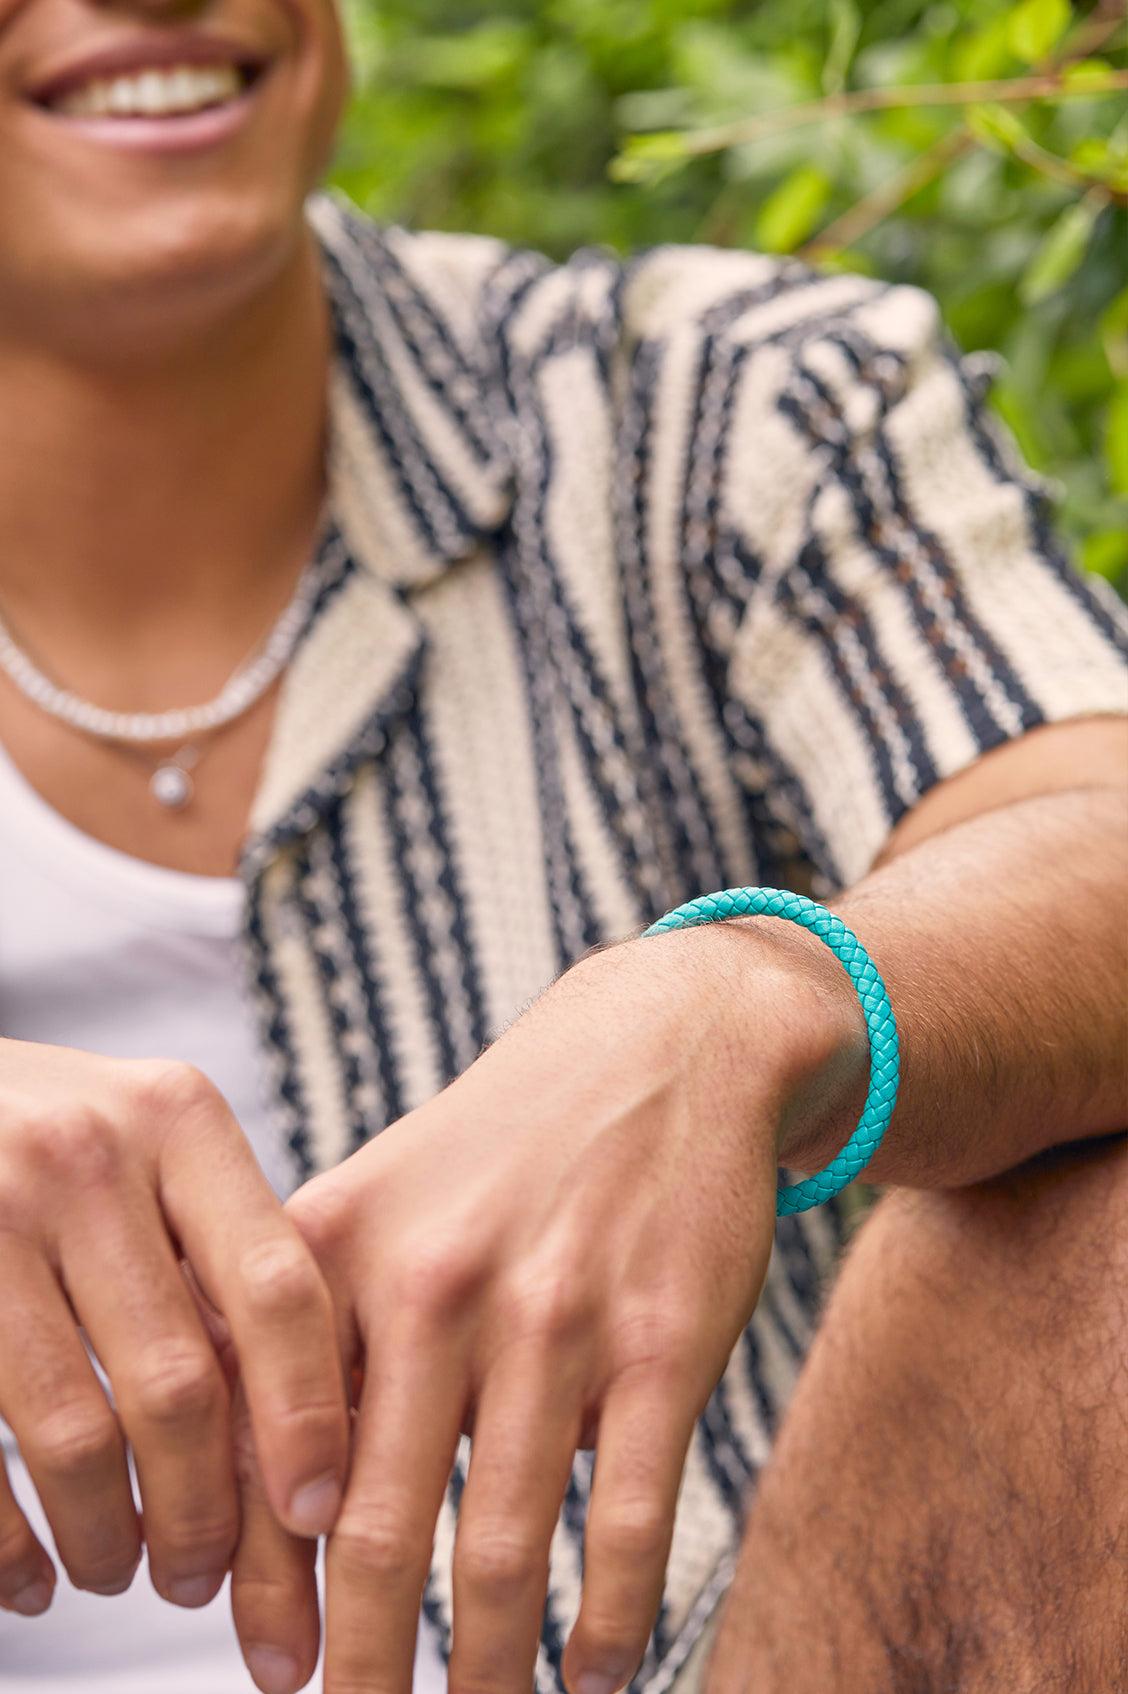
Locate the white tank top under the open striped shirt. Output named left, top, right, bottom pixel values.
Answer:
left=0, top=747, right=447, bottom=1694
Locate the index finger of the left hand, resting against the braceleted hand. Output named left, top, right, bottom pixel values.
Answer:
left=151, top=1067, right=349, bottom=1535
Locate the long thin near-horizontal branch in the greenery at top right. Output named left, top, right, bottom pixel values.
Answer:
left=653, top=71, right=1128, bottom=158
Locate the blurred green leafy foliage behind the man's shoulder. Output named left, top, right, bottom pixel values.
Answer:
left=334, top=0, right=1128, bottom=593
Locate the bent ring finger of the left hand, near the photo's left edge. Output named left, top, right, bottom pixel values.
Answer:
left=0, top=1235, right=141, bottom=1594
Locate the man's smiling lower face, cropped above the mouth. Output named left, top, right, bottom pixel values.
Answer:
left=0, top=0, right=346, bottom=342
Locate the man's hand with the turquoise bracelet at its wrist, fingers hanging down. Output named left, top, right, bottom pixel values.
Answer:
left=232, top=927, right=865, bottom=1694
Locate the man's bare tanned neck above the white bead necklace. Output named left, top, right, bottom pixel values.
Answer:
left=0, top=237, right=329, bottom=710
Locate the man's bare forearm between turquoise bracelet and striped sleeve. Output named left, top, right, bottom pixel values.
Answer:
left=781, top=789, right=1128, bottom=1187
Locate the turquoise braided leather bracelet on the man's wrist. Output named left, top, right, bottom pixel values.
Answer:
left=644, top=888, right=899, bottom=1218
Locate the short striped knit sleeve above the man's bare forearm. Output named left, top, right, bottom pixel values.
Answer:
left=619, top=256, right=1128, bottom=886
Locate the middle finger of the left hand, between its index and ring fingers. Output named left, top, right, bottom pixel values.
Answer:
left=61, top=1172, right=239, bottom=1606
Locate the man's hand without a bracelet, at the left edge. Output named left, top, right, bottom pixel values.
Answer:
left=0, top=1042, right=349, bottom=1613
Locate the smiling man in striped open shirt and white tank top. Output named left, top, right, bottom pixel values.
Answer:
left=0, top=0, right=1125, bottom=1694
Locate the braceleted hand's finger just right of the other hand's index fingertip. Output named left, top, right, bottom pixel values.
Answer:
left=325, top=1333, right=466, bottom=1694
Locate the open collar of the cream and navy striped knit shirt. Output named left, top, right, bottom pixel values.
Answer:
left=242, top=197, right=511, bottom=860
